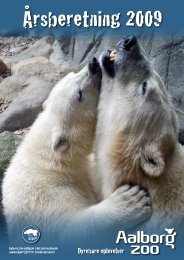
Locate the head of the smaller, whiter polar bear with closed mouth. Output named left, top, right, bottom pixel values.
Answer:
left=43, top=58, right=101, bottom=156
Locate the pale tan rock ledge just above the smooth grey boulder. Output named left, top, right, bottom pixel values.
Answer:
left=0, top=57, right=71, bottom=101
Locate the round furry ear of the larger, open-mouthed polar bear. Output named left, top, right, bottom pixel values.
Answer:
left=140, top=144, right=165, bottom=177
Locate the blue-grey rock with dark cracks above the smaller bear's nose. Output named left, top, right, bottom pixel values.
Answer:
left=50, top=33, right=119, bottom=68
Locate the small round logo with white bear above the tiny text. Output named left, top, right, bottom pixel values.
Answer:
left=22, top=225, right=41, bottom=244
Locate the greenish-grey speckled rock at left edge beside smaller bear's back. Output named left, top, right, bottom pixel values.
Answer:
left=0, top=132, right=22, bottom=176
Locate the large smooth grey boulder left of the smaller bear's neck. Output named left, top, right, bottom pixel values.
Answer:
left=0, top=77, right=54, bottom=133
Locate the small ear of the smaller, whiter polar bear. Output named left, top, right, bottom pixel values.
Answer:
left=52, top=133, right=69, bottom=152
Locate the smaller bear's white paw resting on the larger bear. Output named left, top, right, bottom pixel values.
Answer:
left=104, top=185, right=152, bottom=229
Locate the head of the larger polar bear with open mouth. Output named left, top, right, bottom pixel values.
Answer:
left=100, top=36, right=178, bottom=180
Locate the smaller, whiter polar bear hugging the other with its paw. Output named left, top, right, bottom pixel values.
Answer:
left=2, top=58, right=151, bottom=243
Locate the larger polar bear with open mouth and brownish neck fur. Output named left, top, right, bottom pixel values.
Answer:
left=95, top=36, right=184, bottom=232
